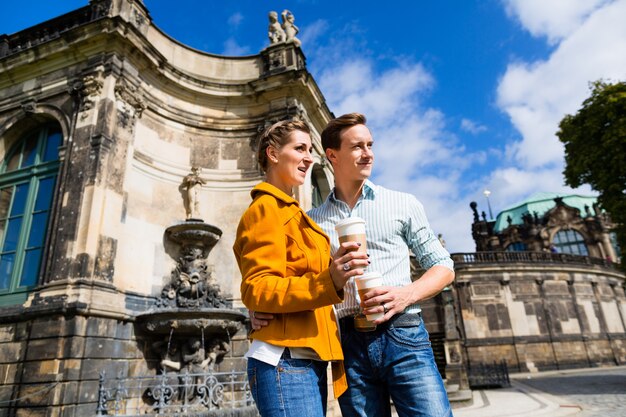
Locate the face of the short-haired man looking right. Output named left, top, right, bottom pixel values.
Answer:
left=326, top=125, right=374, bottom=181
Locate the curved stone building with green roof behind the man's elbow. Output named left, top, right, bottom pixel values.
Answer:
left=453, top=193, right=626, bottom=373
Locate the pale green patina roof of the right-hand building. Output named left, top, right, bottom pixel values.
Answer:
left=494, top=193, right=597, bottom=233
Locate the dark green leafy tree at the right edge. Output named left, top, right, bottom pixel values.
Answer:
left=557, top=81, right=626, bottom=266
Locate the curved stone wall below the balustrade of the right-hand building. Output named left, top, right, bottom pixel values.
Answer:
left=455, top=256, right=626, bottom=372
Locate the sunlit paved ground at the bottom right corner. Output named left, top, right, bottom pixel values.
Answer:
left=453, top=366, right=626, bottom=417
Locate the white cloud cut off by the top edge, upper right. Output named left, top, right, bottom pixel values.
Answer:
left=504, top=0, right=610, bottom=44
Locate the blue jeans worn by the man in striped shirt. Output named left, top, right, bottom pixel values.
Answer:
left=339, top=320, right=452, bottom=417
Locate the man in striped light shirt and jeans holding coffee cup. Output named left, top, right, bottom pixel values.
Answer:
left=253, top=113, right=454, bottom=417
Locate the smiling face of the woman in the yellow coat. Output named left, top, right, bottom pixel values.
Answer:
left=268, top=130, right=313, bottom=195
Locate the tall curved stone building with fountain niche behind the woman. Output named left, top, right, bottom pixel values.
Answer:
left=0, top=0, right=332, bottom=416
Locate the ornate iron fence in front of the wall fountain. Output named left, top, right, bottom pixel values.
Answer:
left=96, top=371, right=256, bottom=417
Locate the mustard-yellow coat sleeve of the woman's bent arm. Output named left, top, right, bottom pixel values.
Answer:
left=233, top=196, right=343, bottom=313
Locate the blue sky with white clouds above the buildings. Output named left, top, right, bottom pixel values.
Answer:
left=0, top=0, right=626, bottom=252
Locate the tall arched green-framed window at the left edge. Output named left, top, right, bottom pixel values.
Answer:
left=0, top=126, right=62, bottom=304
